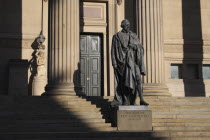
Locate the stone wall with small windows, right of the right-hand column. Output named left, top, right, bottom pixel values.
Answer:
left=163, top=0, right=210, bottom=96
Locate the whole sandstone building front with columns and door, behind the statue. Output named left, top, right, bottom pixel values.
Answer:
left=0, top=0, right=210, bottom=96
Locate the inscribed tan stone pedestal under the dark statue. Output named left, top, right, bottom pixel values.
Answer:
left=117, top=106, right=152, bottom=131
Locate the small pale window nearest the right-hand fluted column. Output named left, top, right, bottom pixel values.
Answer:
left=171, top=64, right=182, bottom=79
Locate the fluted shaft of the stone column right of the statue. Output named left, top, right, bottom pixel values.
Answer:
left=136, top=0, right=164, bottom=85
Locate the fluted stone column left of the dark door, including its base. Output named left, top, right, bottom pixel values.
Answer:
left=46, top=0, right=79, bottom=95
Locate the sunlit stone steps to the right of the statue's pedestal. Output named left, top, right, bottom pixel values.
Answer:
left=147, top=97, right=210, bottom=133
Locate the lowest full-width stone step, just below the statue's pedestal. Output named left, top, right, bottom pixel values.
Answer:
left=0, top=131, right=210, bottom=138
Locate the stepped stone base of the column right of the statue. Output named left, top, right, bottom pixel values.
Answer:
left=143, top=84, right=172, bottom=97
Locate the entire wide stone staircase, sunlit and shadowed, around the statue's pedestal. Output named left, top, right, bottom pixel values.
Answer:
left=0, top=96, right=210, bottom=140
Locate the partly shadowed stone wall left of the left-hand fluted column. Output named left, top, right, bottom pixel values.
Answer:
left=0, top=0, right=48, bottom=95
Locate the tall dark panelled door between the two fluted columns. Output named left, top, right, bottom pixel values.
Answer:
left=80, top=35, right=101, bottom=96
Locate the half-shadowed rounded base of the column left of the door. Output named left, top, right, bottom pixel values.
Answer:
left=42, top=84, right=76, bottom=96
